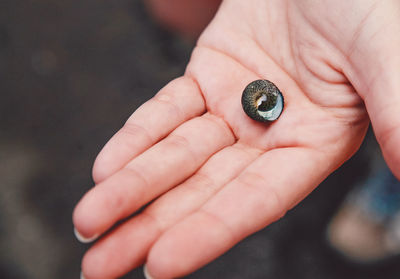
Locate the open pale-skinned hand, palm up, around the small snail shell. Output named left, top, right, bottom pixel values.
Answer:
left=73, top=0, right=400, bottom=279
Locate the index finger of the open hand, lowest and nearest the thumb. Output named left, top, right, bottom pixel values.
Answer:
left=147, top=148, right=332, bottom=278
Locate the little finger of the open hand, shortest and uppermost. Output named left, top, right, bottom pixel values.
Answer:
left=93, top=77, right=205, bottom=183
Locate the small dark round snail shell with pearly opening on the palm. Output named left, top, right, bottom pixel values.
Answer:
left=242, top=79, right=283, bottom=122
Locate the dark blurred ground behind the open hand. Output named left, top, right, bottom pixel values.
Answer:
left=0, top=0, right=400, bottom=279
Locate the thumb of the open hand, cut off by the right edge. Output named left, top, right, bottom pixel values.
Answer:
left=349, top=1, right=400, bottom=178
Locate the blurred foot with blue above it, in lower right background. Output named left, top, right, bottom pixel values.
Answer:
left=327, top=168, right=400, bottom=263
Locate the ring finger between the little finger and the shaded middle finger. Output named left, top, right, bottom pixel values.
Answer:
left=73, top=114, right=235, bottom=241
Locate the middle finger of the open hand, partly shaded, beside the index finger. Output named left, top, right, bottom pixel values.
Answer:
left=82, top=144, right=261, bottom=279
